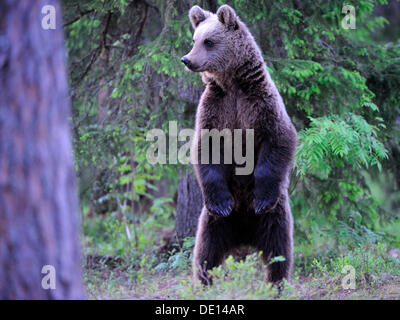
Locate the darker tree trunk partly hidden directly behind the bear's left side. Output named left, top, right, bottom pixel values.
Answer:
left=175, top=172, right=203, bottom=241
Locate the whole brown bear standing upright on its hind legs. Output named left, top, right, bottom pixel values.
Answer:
left=182, top=5, right=297, bottom=284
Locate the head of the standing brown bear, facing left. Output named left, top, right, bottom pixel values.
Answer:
left=181, top=5, right=247, bottom=74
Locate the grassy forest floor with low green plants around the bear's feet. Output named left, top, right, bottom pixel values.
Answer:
left=85, top=239, right=400, bottom=300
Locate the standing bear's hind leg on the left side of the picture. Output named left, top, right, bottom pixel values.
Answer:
left=193, top=207, right=232, bottom=285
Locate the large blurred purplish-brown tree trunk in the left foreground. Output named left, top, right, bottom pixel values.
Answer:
left=0, top=0, right=84, bottom=299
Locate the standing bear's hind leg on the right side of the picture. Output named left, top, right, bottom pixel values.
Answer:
left=256, top=201, right=293, bottom=284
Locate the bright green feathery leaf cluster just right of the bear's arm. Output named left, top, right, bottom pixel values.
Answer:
left=297, top=114, right=387, bottom=180
